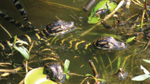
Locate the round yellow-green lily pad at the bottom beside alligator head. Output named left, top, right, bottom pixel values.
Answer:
left=24, top=67, right=57, bottom=84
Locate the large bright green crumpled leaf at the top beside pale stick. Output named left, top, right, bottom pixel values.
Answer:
left=88, top=0, right=117, bottom=24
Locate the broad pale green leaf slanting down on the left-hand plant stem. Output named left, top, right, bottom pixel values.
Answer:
left=14, top=46, right=30, bottom=60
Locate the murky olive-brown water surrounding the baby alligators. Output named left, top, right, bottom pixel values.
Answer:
left=0, top=0, right=150, bottom=84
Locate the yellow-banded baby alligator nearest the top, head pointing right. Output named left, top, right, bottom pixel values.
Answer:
left=0, top=20, right=76, bottom=52
